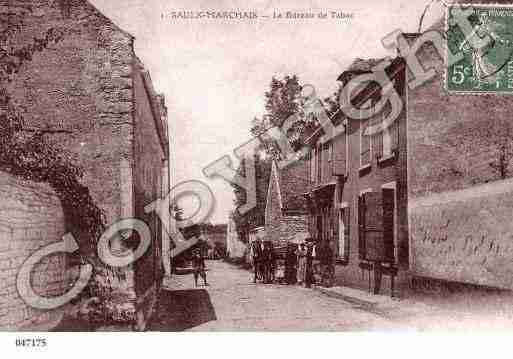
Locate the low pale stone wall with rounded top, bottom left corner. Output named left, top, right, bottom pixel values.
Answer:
left=0, top=172, right=69, bottom=330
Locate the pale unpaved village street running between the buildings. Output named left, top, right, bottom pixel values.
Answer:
left=147, top=261, right=513, bottom=331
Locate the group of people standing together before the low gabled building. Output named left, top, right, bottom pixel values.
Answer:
left=251, top=239, right=326, bottom=287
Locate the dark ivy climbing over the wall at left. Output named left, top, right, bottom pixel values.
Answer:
left=0, top=10, right=105, bottom=259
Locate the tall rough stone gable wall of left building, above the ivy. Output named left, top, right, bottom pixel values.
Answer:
left=0, top=0, right=134, bottom=223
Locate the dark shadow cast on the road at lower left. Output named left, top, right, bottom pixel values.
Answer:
left=146, top=289, right=217, bottom=332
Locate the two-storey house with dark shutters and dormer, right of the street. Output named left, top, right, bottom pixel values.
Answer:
left=306, top=58, right=408, bottom=292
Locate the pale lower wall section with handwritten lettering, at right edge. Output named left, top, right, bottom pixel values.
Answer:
left=410, top=180, right=513, bottom=289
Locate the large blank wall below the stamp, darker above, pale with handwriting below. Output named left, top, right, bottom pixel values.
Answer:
left=407, top=22, right=513, bottom=288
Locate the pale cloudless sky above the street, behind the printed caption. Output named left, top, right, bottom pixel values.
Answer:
left=90, top=0, right=442, bottom=223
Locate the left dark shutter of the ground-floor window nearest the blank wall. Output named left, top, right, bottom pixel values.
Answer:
left=364, top=192, right=385, bottom=261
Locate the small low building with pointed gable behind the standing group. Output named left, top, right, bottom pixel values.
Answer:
left=265, top=161, right=308, bottom=246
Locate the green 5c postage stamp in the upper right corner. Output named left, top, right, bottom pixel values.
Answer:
left=446, top=5, right=513, bottom=93
